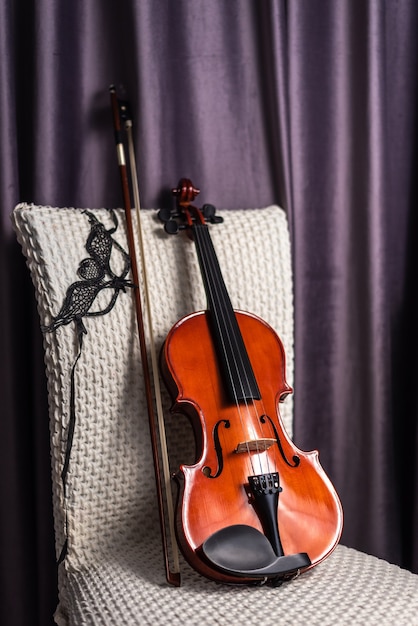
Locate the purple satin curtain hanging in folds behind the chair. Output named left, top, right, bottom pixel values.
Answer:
left=0, top=0, right=418, bottom=626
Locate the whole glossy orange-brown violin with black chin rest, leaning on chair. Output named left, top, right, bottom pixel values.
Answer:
left=160, top=179, right=343, bottom=585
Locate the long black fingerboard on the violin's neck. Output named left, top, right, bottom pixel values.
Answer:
left=192, top=223, right=261, bottom=402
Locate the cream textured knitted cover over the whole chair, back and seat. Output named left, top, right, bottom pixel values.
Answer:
left=13, top=204, right=418, bottom=626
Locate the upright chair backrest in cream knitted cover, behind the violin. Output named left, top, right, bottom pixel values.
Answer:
left=13, top=204, right=293, bottom=568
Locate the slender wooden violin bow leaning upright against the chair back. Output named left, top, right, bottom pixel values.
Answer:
left=109, top=85, right=181, bottom=587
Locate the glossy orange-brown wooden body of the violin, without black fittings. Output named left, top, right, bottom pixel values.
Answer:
left=163, top=312, right=342, bottom=583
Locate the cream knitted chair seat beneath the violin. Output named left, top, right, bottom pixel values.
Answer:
left=58, top=535, right=418, bottom=626
